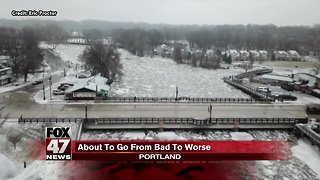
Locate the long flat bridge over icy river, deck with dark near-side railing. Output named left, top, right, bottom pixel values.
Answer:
left=10, top=103, right=306, bottom=129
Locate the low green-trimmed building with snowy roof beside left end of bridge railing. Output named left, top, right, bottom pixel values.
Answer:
left=65, top=75, right=110, bottom=99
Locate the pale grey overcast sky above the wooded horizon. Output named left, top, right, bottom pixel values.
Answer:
left=0, top=0, right=320, bottom=25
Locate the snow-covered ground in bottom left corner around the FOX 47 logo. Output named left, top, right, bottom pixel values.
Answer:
left=0, top=119, right=78, bottom=180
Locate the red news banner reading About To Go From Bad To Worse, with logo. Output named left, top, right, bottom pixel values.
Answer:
left=46, top=127, right=290, bottom=162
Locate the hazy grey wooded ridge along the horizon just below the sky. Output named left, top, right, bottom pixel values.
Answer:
left=0, top=19, right=320, bottom=56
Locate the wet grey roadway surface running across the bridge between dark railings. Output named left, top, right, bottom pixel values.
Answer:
left=1, top=103, right=306, bottom=119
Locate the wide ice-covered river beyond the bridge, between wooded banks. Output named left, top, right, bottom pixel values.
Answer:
left=111, top=49, right=249, bottom=98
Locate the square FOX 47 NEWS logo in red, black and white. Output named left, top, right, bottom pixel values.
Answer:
left=46, top=127, right=72, bottom=160
